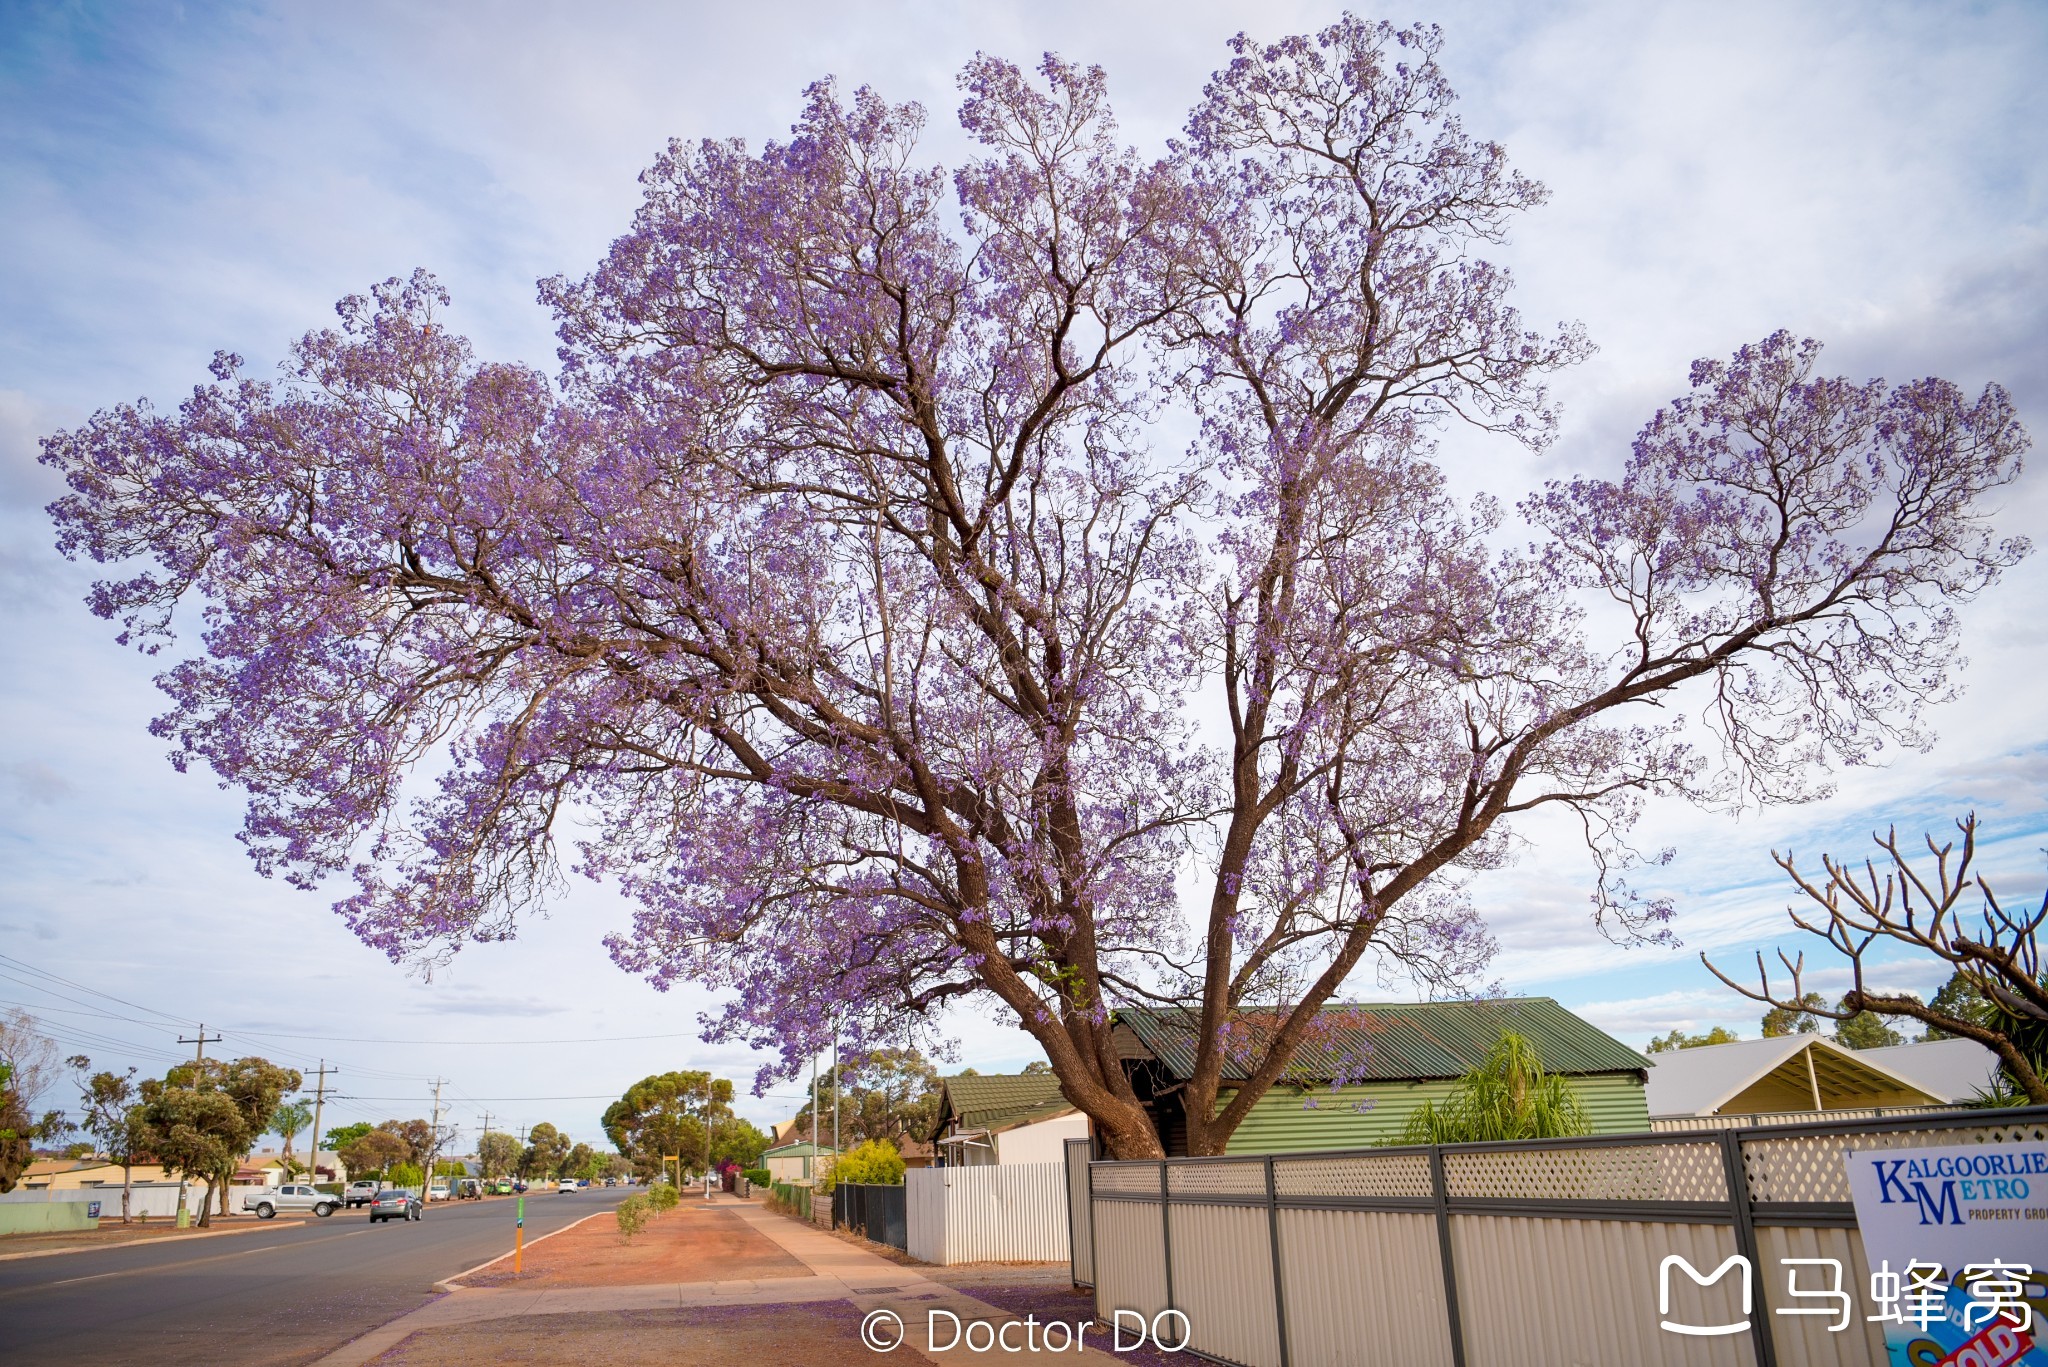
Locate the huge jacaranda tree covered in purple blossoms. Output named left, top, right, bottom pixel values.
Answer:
left=45, top=18, right=2028, bottom=1156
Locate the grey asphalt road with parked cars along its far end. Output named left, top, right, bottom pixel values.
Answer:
left=0, top=1189, right=629, bottom=1367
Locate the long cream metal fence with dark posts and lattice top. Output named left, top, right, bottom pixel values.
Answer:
left=1069, top=1109, right=2048, bottom=1367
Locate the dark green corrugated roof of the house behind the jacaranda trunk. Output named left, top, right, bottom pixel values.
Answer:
left=1116, top=996, right=1651, bottom=1082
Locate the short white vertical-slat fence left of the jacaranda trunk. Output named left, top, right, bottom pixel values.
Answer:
left=903, top=1162, right=1069, bottom=1265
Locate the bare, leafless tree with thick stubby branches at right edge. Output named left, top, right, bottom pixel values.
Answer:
left=1700, top=812, right=2048, bottom=1105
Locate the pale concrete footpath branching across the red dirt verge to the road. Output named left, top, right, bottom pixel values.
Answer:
left=315, top=1195, right=1116, bottom=1367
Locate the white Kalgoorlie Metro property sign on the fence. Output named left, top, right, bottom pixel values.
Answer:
left=1845, top=1142, right=2048, bottom=1367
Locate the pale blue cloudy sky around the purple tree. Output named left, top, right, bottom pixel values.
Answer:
left=0, top=0, right=2048, bottom=1142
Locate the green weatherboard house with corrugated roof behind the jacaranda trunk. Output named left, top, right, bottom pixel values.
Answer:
left=1114, top=996, right=1651, bottom=1154
